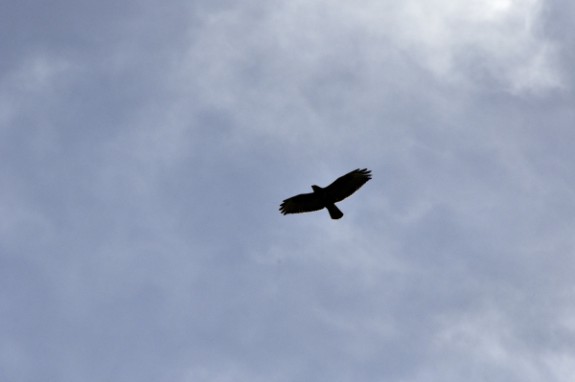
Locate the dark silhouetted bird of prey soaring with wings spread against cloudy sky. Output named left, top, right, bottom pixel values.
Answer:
left=280, top=168, right=371, bottom=219
